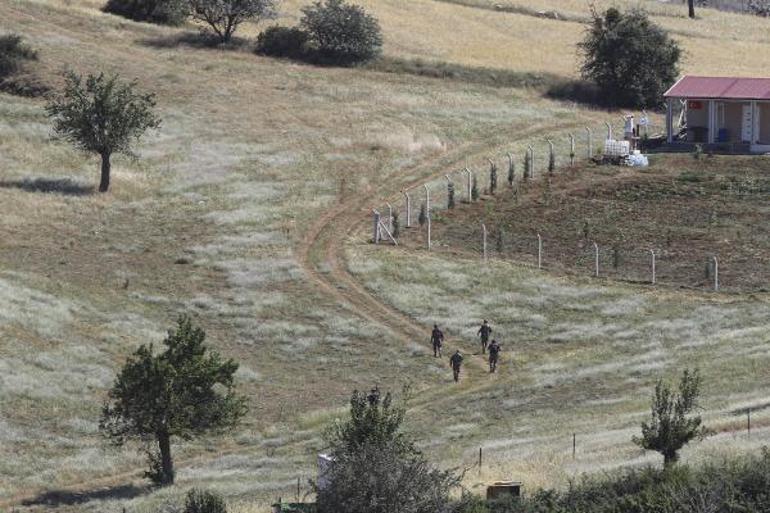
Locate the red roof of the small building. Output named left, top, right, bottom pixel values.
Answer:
left=664, top=75, right=770, bottom=100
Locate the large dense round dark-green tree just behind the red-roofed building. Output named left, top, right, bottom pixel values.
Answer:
left=578, top=7, right=682, bottom=108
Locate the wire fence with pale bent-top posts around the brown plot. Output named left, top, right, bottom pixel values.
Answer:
left=374, top=120, right=770, bottom=291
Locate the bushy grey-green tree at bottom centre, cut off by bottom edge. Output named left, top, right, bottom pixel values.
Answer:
left=315, top=389, right=460, bottom=513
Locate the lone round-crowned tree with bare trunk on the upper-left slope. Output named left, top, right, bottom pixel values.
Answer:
left=46, top=72, right=160, bottom=192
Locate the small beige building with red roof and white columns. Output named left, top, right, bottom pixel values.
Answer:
left=664, top=75, right=770, bottom=153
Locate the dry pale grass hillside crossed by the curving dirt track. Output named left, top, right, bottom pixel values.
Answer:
left=0, top=0, right=770, bottom=512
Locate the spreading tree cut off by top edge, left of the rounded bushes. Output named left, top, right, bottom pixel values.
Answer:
left=190, top=0, right=277, bottom=44
